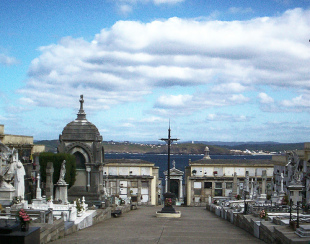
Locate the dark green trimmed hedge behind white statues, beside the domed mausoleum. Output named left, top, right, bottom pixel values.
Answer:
left=39, top=152, right=76, bottom=188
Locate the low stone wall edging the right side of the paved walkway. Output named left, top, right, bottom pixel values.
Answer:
left=206, top=204, right=310, bottom=244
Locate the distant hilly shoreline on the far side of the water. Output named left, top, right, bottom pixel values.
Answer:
left=34, top=140, right=304, bottom=155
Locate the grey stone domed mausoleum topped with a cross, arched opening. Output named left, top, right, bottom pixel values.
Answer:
left=58, top=95, right=104, bottom=201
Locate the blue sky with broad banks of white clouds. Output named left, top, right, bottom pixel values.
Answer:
left=0, top=0, right=310, bottom=143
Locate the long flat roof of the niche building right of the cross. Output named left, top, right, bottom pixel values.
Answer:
left=189, top=159, right=273, bottom=166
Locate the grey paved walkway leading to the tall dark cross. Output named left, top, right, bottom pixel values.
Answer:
left=52, top=206, right=264, bottom=244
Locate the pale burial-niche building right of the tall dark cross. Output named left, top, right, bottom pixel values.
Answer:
left=185, top=148, right=273, bottom=206
